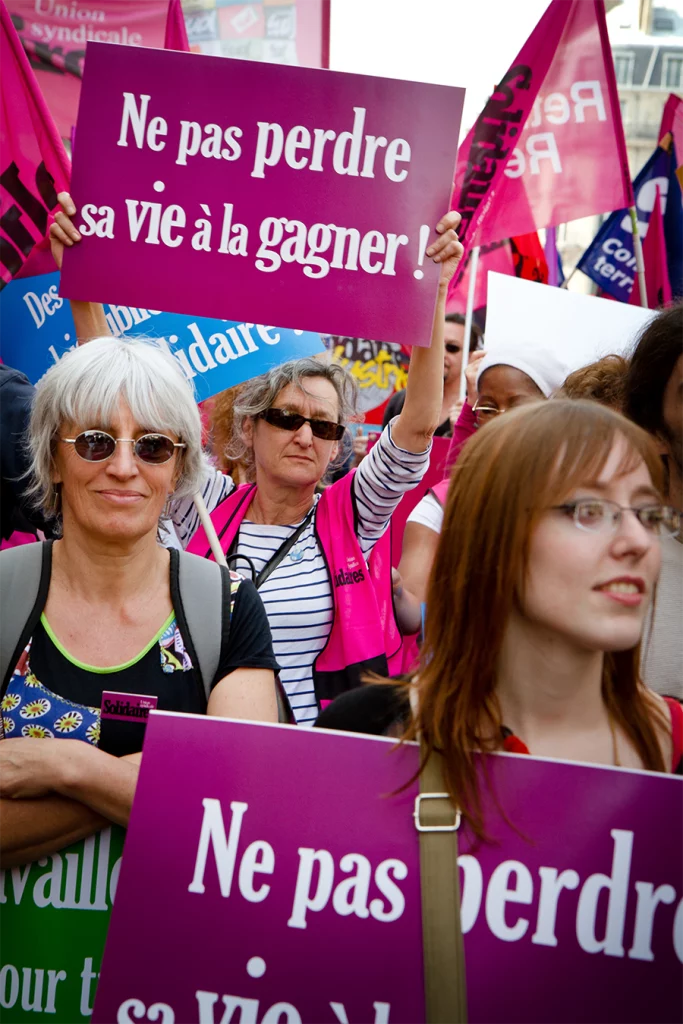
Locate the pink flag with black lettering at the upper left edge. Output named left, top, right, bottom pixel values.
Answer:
left=0, top=0, right=71, bottom=290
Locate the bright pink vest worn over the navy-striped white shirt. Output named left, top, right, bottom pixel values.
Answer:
left=187, top=470, right=402, bottom=707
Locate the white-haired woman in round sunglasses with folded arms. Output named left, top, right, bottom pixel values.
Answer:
left=0, top=338, right=278, bottom=866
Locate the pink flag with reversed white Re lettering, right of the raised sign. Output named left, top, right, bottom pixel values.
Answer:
left=454, top=0, right=633, bottom=268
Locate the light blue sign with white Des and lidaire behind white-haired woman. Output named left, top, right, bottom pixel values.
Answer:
left=0, top=271, right=325, bottom=401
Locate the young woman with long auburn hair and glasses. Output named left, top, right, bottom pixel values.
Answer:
left=318, top=400, right=683, bottom=835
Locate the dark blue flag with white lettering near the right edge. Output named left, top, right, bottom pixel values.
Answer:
left=578, top=146, right=671, bottom=302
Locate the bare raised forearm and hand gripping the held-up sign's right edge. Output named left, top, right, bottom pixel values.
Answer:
left=392, top=210, right=463, bottom=452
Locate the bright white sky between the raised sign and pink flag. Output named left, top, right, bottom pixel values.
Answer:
left=330, top=0, right=550, bottom=137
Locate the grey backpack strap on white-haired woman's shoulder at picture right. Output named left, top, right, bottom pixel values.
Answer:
left=171, top=550, right=230, bottom=702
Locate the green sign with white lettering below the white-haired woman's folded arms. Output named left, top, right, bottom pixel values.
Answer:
left=0, top=825, right=126, bottom=1024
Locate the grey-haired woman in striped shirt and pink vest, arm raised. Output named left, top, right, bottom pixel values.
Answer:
left=184, top=212, right=462, bottom=725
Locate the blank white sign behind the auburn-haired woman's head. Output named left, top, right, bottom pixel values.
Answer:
left=486, top=273, right=654, bottom=374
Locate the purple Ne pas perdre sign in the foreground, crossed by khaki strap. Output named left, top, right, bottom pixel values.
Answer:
left=93, top=712, right=683, bottom=1024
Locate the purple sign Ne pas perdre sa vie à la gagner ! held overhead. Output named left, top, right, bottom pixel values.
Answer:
left=61, top=43, right=464, bottom=345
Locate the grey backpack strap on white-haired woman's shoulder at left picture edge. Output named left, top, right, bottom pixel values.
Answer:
left=0, top=541, right=52, bottom=696
